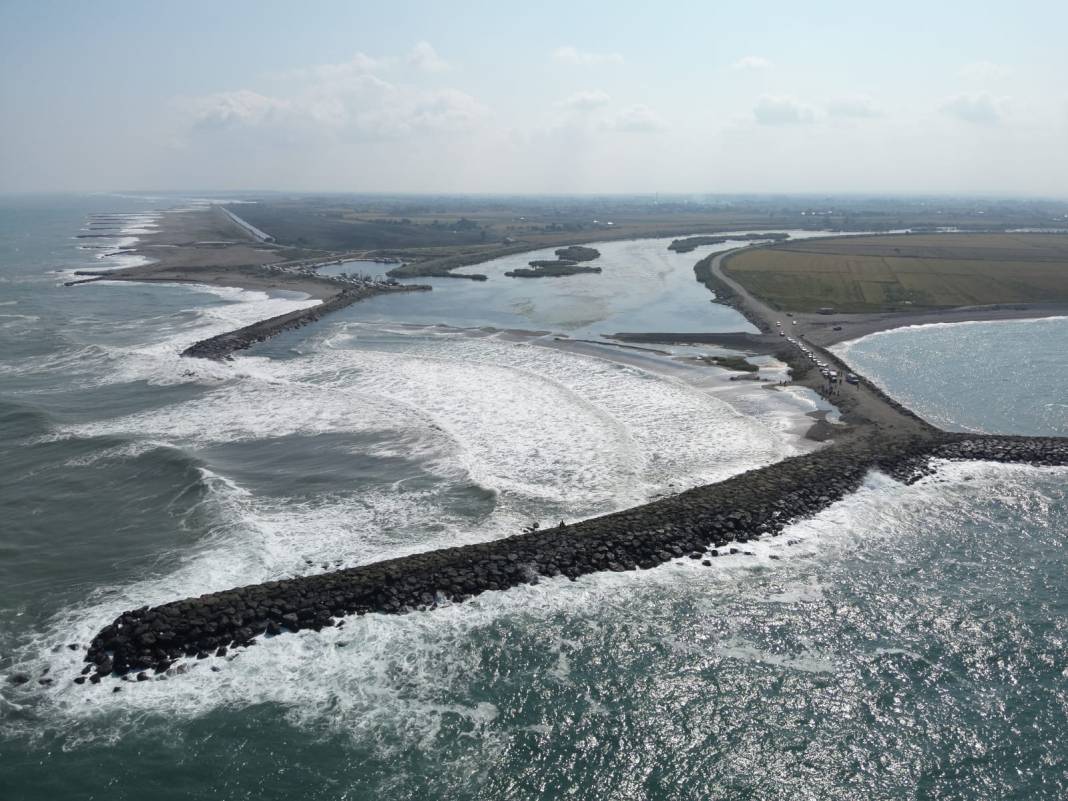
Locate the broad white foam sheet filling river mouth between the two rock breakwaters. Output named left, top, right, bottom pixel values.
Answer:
left=65, top=326, right=796, bottom=522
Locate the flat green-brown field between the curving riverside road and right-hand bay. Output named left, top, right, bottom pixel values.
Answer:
left=724, top=234, right=1068, bottom=312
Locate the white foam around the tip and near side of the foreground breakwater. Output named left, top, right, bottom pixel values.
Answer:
left=14, top=462, right=1068, bottom=752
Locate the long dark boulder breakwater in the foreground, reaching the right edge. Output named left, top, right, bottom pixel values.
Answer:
left=76, top=433, right=1068, bottom=684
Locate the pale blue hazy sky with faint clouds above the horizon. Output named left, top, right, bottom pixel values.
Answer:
left=0, top=0, right=1068, bottom=198
